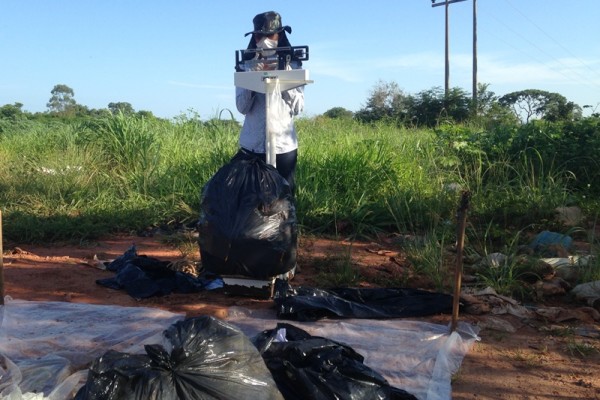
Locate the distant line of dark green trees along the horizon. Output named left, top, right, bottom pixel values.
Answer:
left=0, top=81, right=600, bottom=127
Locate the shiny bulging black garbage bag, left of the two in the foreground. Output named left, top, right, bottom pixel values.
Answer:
left=75, top=316, right=283, bottom=400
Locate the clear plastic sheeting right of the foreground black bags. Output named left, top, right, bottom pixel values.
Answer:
left=228, top=307, right=479, bottom=400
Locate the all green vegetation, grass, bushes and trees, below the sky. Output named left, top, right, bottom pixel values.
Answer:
left=0, top=83, right=600, bottom=294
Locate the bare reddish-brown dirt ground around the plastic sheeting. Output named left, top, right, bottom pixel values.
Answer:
left=4, top=236, right=600, bottom=399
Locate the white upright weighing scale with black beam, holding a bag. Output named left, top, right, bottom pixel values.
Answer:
left=221, top=46, right=313, bottom=297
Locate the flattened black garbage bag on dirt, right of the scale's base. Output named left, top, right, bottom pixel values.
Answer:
left=273, top=279, right=452, bottom=321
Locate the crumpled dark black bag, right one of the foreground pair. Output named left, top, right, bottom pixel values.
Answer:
left=252, top=323, right=416, bottom=400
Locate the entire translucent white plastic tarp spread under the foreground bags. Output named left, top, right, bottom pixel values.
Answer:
left=0, top=298, right=478, bottom=400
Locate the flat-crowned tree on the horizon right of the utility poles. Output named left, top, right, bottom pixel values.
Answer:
left=498, top=89, right=581, bottom=123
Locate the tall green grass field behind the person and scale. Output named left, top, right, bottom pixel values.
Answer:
left=0, top=114, right=596, bottom=245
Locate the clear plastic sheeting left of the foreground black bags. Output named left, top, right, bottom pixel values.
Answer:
left=0, top=297, right=185, bottom=400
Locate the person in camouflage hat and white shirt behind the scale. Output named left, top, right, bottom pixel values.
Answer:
left=235, top=11, right=304, bottom=195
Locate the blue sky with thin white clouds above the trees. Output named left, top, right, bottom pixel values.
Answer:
left=0, top=0, right=600, bottom=120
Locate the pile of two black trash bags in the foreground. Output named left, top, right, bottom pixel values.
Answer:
left=75, top=316, right=416, bottom=400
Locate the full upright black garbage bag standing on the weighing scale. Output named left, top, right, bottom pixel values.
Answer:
left=198, top=153, right=298, bottom=279
